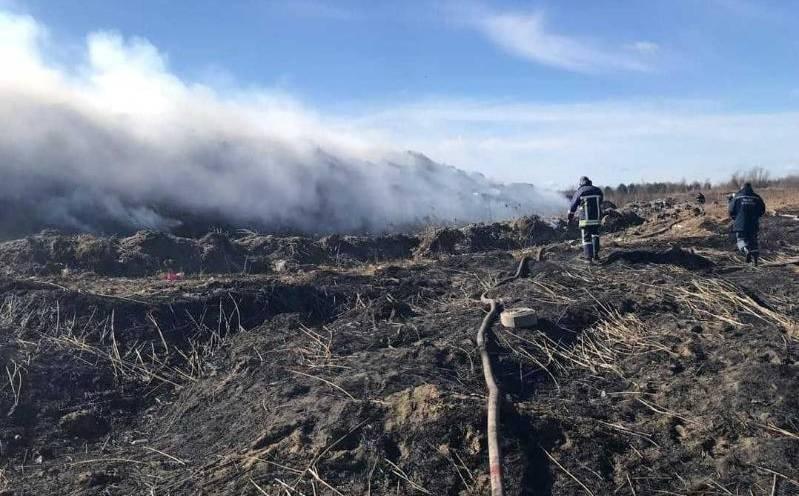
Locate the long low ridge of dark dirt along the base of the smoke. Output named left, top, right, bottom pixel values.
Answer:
left=0, top=216, right=567, bottom=277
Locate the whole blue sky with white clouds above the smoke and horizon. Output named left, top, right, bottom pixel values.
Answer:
left=0, top=0, right=799, bottom=185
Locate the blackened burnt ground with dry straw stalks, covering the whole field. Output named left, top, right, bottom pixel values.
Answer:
left=0, top=202, right=799, bottom=496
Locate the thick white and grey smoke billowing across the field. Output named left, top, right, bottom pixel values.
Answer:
left=0, top=12, right=562, bottom=235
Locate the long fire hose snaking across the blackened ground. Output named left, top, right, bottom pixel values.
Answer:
left=477, top=253, right=541, bottom=496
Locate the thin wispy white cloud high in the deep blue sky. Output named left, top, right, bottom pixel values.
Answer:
left=451, top=5, right=654, bottom=73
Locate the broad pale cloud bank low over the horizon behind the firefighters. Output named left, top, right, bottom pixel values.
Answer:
left=352, top=100, right=799, bottom=185
